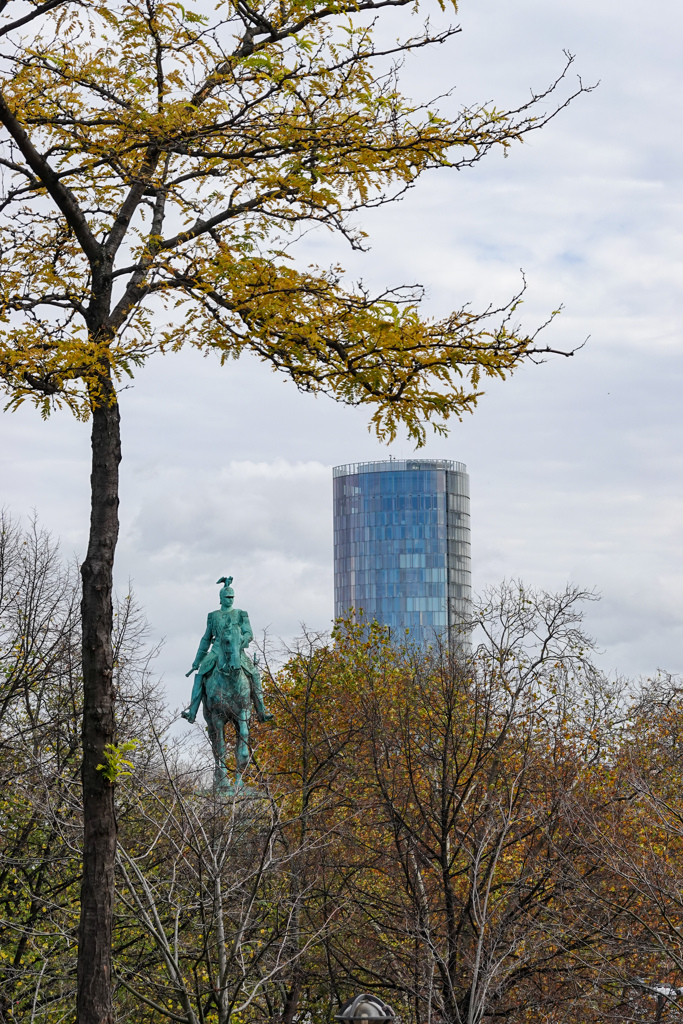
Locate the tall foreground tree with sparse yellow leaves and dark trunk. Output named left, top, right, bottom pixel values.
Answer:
left=0, top=0, right=583, bottom=1024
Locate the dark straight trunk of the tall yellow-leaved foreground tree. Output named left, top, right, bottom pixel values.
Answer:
left=77, top=389, right=121, bottom=1024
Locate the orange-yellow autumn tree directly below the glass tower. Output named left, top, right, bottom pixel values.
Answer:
left=256, top=584, right=623, bottom=1024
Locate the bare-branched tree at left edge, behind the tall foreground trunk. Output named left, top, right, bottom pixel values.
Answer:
left=0, top=513, right=162, bottom=1021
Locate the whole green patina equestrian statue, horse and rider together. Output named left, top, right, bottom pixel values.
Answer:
left=182, top=577, right=272, bottom=791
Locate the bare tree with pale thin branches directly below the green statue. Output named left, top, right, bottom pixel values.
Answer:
left=115, top=752, right=342, bottom=1024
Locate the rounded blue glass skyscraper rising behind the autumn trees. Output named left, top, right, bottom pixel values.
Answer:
left=333, top=459, right=471, bottom=640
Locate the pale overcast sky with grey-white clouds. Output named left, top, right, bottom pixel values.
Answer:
left=0, top=0, right=683, bottom=702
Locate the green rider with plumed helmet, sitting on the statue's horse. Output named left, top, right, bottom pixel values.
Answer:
left=182, top=577, right=272, bottom=722
